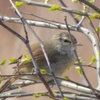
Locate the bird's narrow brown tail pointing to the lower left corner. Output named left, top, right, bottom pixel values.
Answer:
left=0, top=76, right=19, bottom=93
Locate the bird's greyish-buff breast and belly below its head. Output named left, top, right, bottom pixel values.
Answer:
left=46, top=50, right=76, bottom=76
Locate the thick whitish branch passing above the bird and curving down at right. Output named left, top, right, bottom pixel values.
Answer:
left=0, top=16, right=100, bottom=85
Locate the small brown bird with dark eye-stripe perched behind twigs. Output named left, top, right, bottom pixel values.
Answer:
left=0, top=32, right=78, bottom=93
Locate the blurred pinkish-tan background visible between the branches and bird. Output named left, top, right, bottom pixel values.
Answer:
left=0, top=0, right=98, bottom=100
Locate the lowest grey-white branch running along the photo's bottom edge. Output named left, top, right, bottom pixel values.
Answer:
left=0, top=90, right=98, bottom=100
